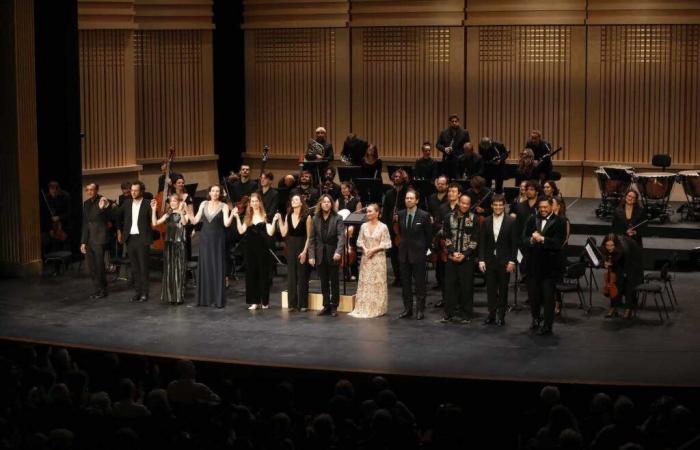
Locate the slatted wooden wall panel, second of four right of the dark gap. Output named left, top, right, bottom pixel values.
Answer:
left=352, top=27, right=464, bottom=159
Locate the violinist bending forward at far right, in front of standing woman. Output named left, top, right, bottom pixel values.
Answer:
left=600, top=233, right=644, bottom=319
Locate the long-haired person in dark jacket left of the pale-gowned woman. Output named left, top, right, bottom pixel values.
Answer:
left=309, top=194, right=343, bottom=317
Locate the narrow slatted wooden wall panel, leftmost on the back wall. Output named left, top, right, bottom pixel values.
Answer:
left=79, top=30, right=134, bottom=169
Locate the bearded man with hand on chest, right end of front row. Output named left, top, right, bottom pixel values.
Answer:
left=522, top=198, right=566, bottom=335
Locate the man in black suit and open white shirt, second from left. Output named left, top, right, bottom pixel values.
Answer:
left=113, top=181, right=153, bottom=302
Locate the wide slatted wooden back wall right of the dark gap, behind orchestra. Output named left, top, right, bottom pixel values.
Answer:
left=243, top=0, right=700, bottom=196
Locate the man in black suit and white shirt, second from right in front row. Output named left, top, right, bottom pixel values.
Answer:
left=479, top=194, right=518, bottom=326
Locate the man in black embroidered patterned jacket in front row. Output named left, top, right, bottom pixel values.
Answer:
left=440, top=194, right=479, bottom=324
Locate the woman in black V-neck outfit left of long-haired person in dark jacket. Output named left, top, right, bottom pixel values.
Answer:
left=280, top=194, right=312, bottom=312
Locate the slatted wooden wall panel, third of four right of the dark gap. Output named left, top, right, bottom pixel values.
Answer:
left=467, top=25, right=585, bottom=160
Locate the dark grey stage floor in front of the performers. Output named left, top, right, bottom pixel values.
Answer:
left=0, top=260, right=700, bottom=386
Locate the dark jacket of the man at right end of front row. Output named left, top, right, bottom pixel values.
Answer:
left=522, top=214, right=566, bottom=278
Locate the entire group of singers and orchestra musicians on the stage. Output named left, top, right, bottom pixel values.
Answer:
left=64, top=115, right=645, bottom=335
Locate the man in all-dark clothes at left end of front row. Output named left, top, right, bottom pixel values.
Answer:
left=80, top=183, right=109, bottom=299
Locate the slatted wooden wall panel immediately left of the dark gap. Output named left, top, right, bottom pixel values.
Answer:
left=134, top=30, right=214, bottom=160
